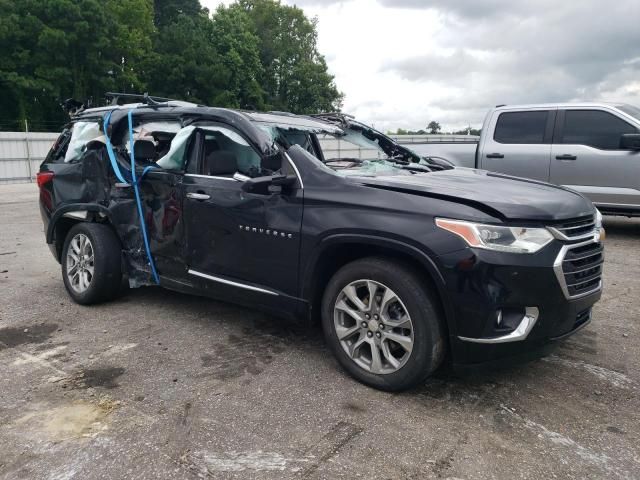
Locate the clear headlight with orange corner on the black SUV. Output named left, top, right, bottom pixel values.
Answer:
left=436, top=218, right=553, bottom=253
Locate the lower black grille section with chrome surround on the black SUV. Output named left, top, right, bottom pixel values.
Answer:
left=555, top=242, right=604, bottom=298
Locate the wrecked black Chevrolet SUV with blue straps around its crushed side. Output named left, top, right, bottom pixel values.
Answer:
left=37, top=98, right=603, bottom=390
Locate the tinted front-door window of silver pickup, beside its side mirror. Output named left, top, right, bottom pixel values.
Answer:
left=558, top=110, right=638, bottom=150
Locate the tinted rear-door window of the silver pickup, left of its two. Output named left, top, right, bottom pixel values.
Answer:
left=493, top=110, right=549, bottom=144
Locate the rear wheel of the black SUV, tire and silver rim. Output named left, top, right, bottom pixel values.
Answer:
left=60, top=223, right=122, bottom=305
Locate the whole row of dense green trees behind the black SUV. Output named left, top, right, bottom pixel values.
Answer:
left=0, top=0, right=342, bottom=130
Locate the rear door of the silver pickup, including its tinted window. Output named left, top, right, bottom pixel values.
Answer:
left=479, top=109, right=556, bottom=182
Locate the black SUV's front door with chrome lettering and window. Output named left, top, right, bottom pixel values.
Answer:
left=183, top=126, right=302, bottom=304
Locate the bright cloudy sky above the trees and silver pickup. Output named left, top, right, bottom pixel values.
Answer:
left=201, top=0, right=640, bottom=131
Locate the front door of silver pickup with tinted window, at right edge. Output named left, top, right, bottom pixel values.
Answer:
left=551, top=108, right=640, bottom=206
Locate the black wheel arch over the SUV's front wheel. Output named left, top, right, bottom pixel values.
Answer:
left=301, top=234, right=453, bottom=337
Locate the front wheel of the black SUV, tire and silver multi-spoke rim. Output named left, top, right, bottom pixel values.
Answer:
left=322, top=257, right=445, bottom=391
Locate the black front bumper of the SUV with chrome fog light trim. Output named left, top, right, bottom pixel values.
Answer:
left=439, top=242, right=602, bottom=366
